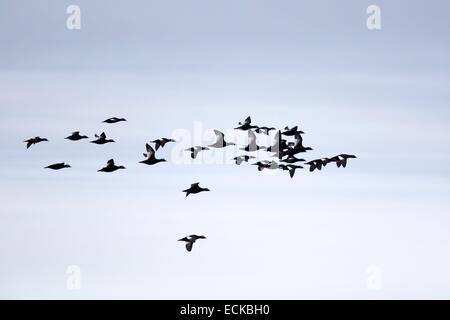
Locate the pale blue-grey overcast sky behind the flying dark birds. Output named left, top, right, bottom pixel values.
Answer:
left=0, top=0, right=450, bottom=299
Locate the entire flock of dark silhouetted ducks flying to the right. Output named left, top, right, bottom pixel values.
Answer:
left=24, top=116, right=356, bottom=252
